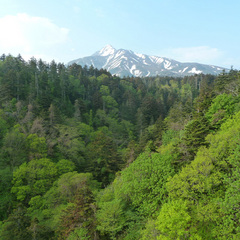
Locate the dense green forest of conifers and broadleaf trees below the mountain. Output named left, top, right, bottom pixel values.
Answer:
left=0, top=55, right=240, bottom=240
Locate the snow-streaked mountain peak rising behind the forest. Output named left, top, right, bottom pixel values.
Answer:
left=68, top=45, right=227, bottom=77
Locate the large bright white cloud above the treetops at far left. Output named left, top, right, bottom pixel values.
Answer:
left=0, top=14, right=69, bottom=60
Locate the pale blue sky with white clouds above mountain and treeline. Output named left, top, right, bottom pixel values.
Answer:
left=0, top=0, right=240, bottom=69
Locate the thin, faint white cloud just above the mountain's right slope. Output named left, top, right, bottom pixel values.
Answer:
left=164, top=46, right=223, bottom=64
